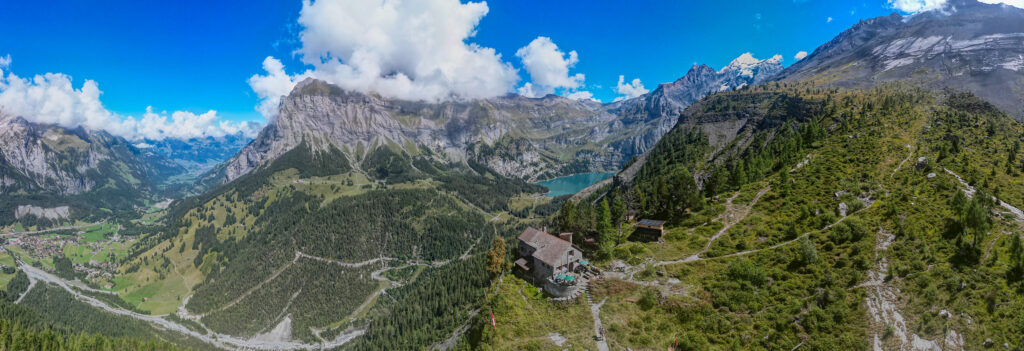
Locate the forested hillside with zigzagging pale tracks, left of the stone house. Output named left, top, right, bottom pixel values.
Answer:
left=96, top=127, right=550, bottom=350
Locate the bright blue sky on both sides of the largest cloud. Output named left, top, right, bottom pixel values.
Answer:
left=0, top=0, right=894, bottom=132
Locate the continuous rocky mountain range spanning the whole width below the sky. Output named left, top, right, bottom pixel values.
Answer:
left=8, top=0, right=1024, bottom=228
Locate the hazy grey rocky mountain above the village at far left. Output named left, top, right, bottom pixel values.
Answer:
left=0, top=114, right=184, bottom=221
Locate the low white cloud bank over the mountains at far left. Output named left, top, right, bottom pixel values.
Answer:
left=0, top=59, right=260, bottom=140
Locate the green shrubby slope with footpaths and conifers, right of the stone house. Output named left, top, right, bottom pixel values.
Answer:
left=528, top=83, right=1024, bottom=350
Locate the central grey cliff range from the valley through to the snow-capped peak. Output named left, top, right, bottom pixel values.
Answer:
left=222, top=54, right=782, bottom=181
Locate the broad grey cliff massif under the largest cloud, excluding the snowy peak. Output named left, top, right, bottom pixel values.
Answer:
left=224, top=80, right=622, bottom=181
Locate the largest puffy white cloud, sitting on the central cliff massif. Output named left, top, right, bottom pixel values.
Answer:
left=276, top=0, right=519, bottom=105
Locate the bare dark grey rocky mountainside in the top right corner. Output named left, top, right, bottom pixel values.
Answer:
left=777, top=0, right=1024, bottom=120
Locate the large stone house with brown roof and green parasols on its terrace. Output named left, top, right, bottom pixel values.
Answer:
left=515, top=228, right=587, bottom=297
